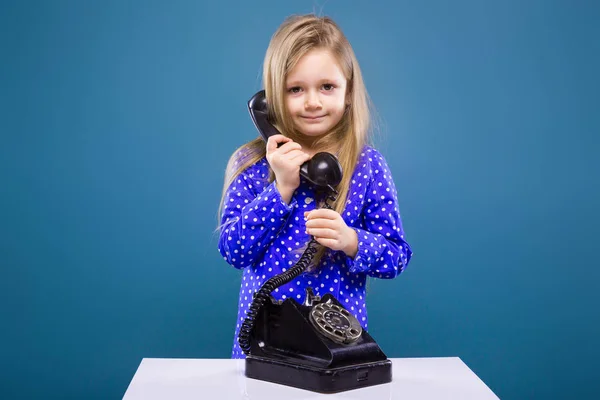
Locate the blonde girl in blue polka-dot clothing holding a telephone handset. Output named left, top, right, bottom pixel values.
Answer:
left=219, top=15, right=412, bottom=358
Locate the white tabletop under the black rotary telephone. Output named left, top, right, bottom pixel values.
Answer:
left=123, top=357, right=498, bottom=400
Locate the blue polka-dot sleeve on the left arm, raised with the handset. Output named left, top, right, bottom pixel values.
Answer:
left=219, top=164, right=296, bottom=269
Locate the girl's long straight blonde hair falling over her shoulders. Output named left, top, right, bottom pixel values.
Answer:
left=219, top=14, right=370, bottom=265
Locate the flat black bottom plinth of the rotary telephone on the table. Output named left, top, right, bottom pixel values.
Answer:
left=246, top=355, right=392, bottom=393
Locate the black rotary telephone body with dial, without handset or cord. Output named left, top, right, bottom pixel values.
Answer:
left=246, top=288, right=392, bottom=393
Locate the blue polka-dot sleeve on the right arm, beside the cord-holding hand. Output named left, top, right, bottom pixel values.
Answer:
left=346, top=152, right=412, bottom=279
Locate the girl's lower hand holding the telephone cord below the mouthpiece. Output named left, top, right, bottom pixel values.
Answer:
left=304, top=208, right=358, bottom=257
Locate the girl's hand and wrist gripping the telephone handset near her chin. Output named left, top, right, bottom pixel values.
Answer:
left=267, top=135, right=310, bottom=203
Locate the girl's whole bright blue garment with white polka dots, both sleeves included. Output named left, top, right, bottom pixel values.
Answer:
left=219, top=146, right=412, bottom=358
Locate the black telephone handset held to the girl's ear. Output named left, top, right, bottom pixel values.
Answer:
left=248, top=90, right=342, bottom=192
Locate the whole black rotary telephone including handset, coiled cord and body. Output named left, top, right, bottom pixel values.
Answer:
left=238, top=90, right=392, bottom=393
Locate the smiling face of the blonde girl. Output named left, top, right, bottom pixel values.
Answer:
left=285, top=49, right=346, bottom=142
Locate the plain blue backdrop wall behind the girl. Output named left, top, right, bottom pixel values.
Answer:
left=0, top=0, right=600, bottom=399
